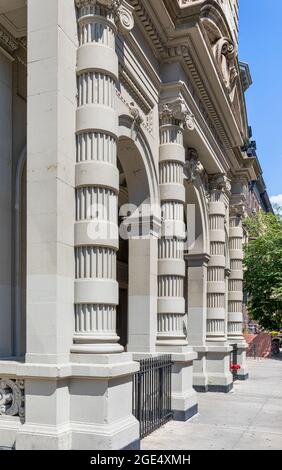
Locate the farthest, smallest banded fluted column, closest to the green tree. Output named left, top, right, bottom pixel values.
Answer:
left=227, top=204, right=248, bottom=380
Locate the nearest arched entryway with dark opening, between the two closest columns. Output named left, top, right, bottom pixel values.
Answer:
left=117, top=115, right=160, bottom=352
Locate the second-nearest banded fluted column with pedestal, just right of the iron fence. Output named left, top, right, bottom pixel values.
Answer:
left=157, top=98, right=198, bottom=420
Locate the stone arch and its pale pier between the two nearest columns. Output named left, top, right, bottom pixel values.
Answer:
left=118, top=115, right=159, bottom=352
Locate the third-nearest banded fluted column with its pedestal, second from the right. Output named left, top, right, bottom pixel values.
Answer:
left=206, top=175, right=233, bottom=391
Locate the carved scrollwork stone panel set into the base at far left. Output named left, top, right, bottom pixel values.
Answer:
left=0, top=378, right=24, bottom=420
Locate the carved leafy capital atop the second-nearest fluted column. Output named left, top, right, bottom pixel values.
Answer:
left=159, top=97, right=195, bottom=130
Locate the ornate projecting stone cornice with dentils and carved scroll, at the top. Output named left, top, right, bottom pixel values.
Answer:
left=130, top=0, right=247, bottom=165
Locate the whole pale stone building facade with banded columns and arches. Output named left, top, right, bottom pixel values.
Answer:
left=0, top=0, right=270, bottom=450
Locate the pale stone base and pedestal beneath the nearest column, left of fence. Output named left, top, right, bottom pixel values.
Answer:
left=0, top=353, right=140, bottom=450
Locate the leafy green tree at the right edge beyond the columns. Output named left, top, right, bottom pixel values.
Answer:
left=244, top=208, right=282, bottom=330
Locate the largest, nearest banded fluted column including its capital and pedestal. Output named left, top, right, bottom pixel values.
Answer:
left=70, top=0, right=140, bottom=450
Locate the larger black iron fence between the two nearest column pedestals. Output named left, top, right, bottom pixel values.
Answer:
left=132, top=355, right=172, bottom=439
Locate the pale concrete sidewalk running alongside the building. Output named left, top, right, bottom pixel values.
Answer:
left=141, top=353, right=282, bottom=450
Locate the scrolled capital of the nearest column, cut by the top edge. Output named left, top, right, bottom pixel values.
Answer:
left=75, top=0, right=134, bottom=34
